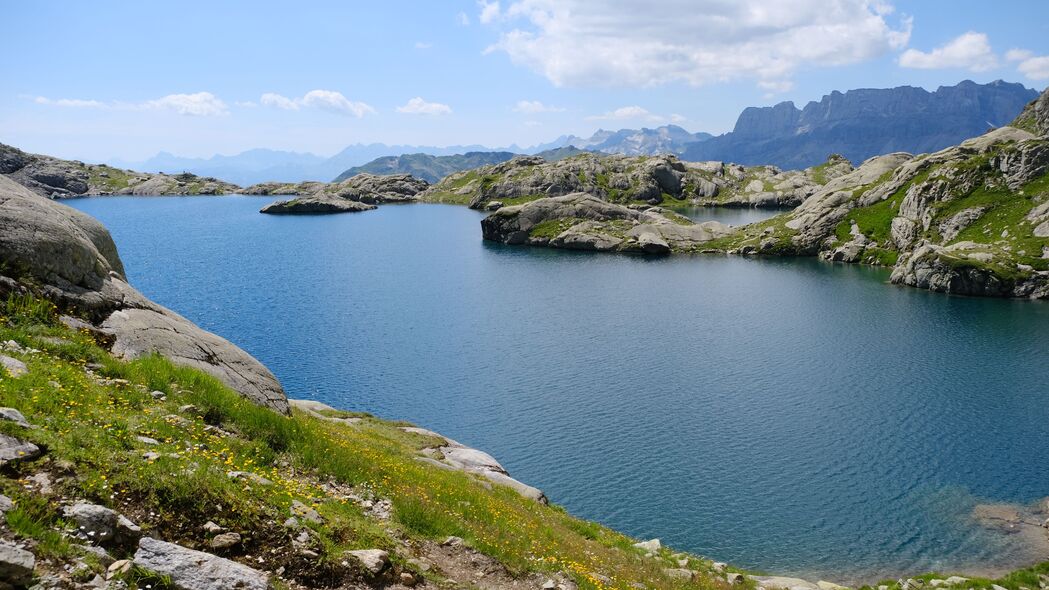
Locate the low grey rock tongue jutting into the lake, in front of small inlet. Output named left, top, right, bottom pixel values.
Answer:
left=480, top=193, right=733, bottom=254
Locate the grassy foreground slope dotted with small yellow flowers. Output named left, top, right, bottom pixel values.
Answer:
left=0, top=291, right=734, bottom=589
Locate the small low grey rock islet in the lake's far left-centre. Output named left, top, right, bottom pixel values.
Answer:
left=253, top=174, right=430, bottom=214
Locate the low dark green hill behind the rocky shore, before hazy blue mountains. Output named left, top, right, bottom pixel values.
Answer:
left=334, top=146, right=584, bottom=183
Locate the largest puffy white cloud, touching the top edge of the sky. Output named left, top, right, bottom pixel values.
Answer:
left=481, top=0, right=911, bottom=86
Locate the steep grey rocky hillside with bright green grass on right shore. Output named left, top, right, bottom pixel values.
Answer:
left=730, top=91, right=1049, bottom=298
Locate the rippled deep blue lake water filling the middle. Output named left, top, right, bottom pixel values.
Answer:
left=68, top=196, right=1049, bottom=582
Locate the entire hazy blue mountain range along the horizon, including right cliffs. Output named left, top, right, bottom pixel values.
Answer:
left=106, top=80, right=1039, bottom=185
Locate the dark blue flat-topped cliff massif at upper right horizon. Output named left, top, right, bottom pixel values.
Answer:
left=682, top=80, right=1039, bottom=169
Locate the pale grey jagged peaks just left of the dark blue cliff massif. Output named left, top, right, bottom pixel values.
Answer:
left=536, top=125, right=713, bottom=155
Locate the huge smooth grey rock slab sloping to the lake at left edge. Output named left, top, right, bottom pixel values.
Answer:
left=0, top=177, right=288, bottom=414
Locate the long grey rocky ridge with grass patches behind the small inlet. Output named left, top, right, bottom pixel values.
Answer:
left=420, top=153, right=852, bottom=209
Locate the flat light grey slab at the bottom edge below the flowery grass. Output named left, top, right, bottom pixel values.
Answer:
left=134, top=536, right=270, bottom=590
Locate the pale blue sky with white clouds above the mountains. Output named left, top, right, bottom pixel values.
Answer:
left=0, top=0, right=1049, bottom=162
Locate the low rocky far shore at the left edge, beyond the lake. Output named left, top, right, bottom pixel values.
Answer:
left=0, top=144, right=239, bottom=198
